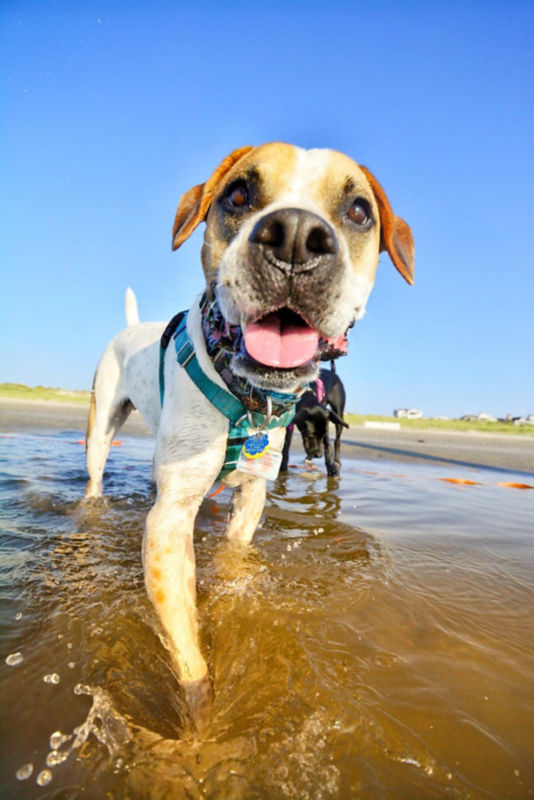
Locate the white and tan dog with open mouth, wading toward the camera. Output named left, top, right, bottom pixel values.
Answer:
left=86, top=143, right=413, bottom=721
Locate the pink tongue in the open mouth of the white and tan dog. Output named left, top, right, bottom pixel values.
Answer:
left=245, top=313, right=319, bottom=369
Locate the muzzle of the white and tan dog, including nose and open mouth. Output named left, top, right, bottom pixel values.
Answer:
left=230, top=208, right=348, bottom=390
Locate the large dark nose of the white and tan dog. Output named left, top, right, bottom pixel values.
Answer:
left=250, top=208, right=337, bottom=268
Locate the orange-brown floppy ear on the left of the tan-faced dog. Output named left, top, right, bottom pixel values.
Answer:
left=172, top=145, right=254, bottom=250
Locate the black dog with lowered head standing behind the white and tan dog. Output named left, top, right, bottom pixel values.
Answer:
left=280, top=369, right=349, bottom=475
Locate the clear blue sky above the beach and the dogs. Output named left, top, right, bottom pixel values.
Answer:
left=0, top=0, right=534, bottom=415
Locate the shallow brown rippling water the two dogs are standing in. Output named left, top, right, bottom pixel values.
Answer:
left=0, top=432, right=534, bottom=800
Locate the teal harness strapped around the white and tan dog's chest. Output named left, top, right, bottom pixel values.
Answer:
left=159, top=311, right=301, bottom=479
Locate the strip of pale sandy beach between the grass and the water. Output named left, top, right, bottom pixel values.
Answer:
left=0, top=398, right=534, bottom=475
